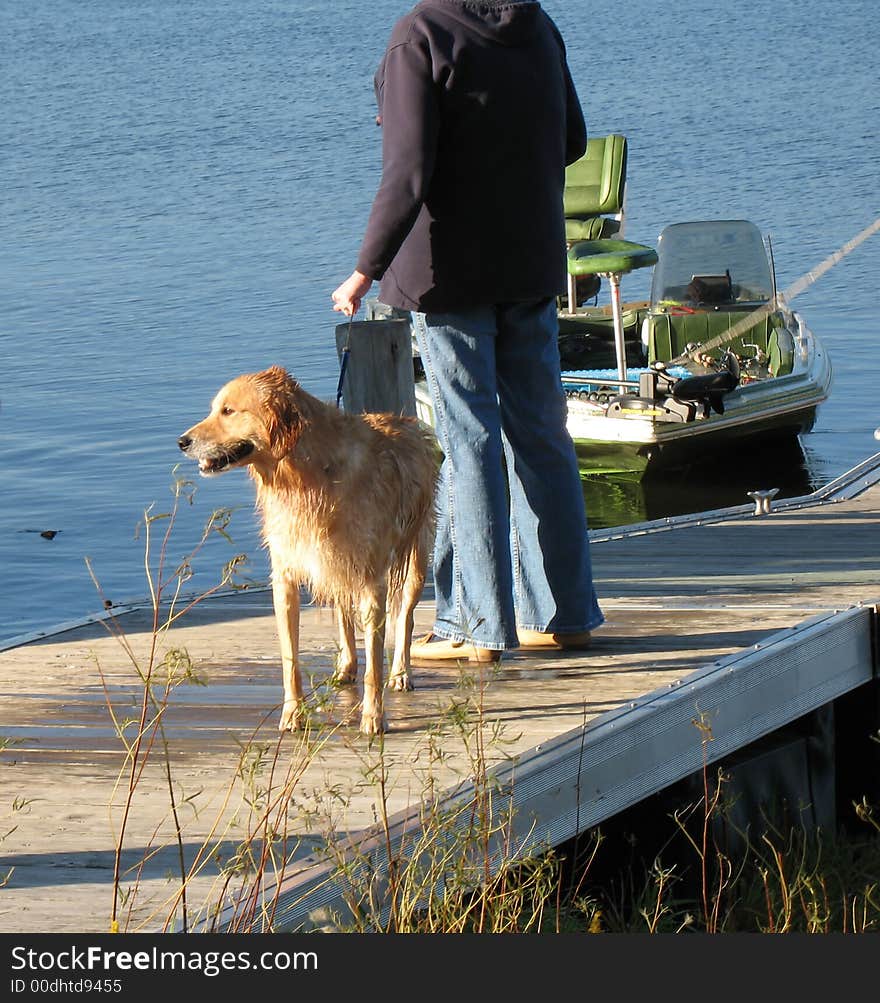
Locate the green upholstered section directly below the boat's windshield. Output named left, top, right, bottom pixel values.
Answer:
left=645, top=310, right=782, bottom=371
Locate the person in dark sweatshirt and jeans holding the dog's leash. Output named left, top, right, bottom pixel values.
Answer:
left=332, top=0, right=604, bottom=662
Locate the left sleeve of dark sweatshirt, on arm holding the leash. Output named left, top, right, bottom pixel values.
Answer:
left=356, top=36, right=438, bottom=279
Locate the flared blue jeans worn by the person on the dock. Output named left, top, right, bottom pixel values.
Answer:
left=412, top=300, right=605, bottom=650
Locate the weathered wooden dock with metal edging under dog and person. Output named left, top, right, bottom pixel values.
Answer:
left=0, top=454, right=880, bottom=933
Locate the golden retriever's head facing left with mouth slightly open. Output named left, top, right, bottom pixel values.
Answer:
left=178, top=366, right=303, bottom=476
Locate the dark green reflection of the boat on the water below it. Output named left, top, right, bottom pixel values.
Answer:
left=578, top=439, right=822, bottom=530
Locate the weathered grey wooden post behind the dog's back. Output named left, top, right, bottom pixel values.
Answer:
left=336, top=318, right=415, bottom=416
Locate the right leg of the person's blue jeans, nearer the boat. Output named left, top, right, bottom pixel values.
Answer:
left=496, top=292, right=605, bottom=633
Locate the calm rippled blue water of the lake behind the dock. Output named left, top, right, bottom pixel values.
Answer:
left=0, top=0, right=880, bottom=640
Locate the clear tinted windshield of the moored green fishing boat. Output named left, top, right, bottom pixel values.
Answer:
left=651, top=220, right=773, bottom=310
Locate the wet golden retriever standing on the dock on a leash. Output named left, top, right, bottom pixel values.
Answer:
left=178, top=366, right=437, bottom=734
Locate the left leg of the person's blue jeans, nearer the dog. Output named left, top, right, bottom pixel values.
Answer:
left=412, top=307, right=518, bottom=650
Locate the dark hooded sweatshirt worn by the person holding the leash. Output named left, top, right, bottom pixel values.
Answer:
left=357, top=0, right=587, bottom=312
